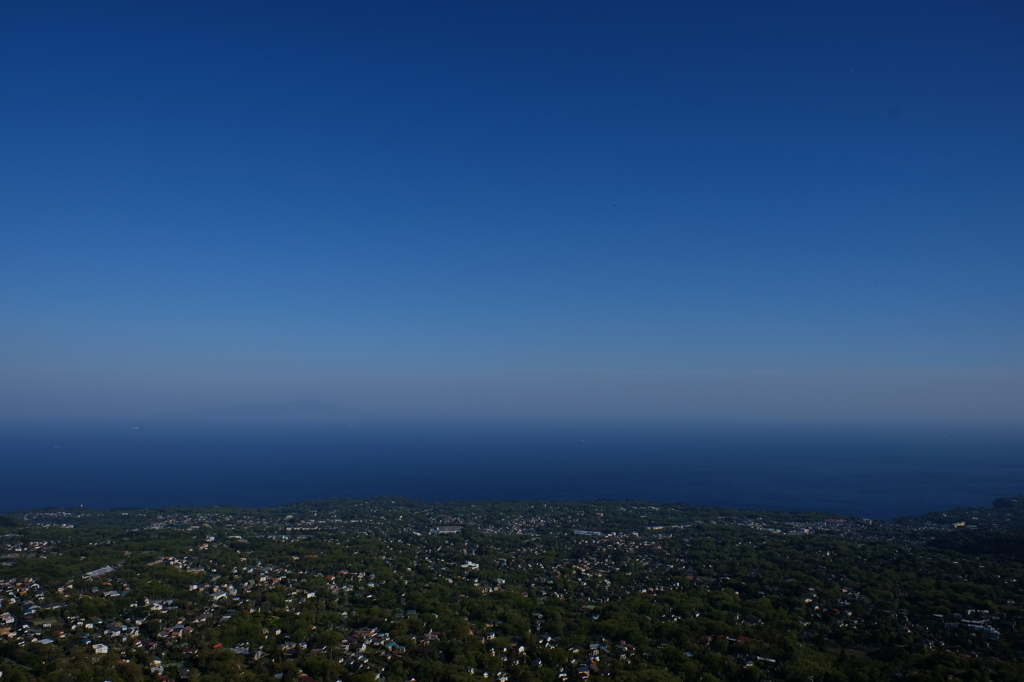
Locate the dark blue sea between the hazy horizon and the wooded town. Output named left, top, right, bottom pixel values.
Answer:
left=6, top=422, right=1024, bottom=519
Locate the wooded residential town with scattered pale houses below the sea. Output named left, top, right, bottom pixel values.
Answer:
left=0, top=499, right=1024, bottom=682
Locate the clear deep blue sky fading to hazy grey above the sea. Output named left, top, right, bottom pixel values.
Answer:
left=0, top=0, right=1024, bottom=424
